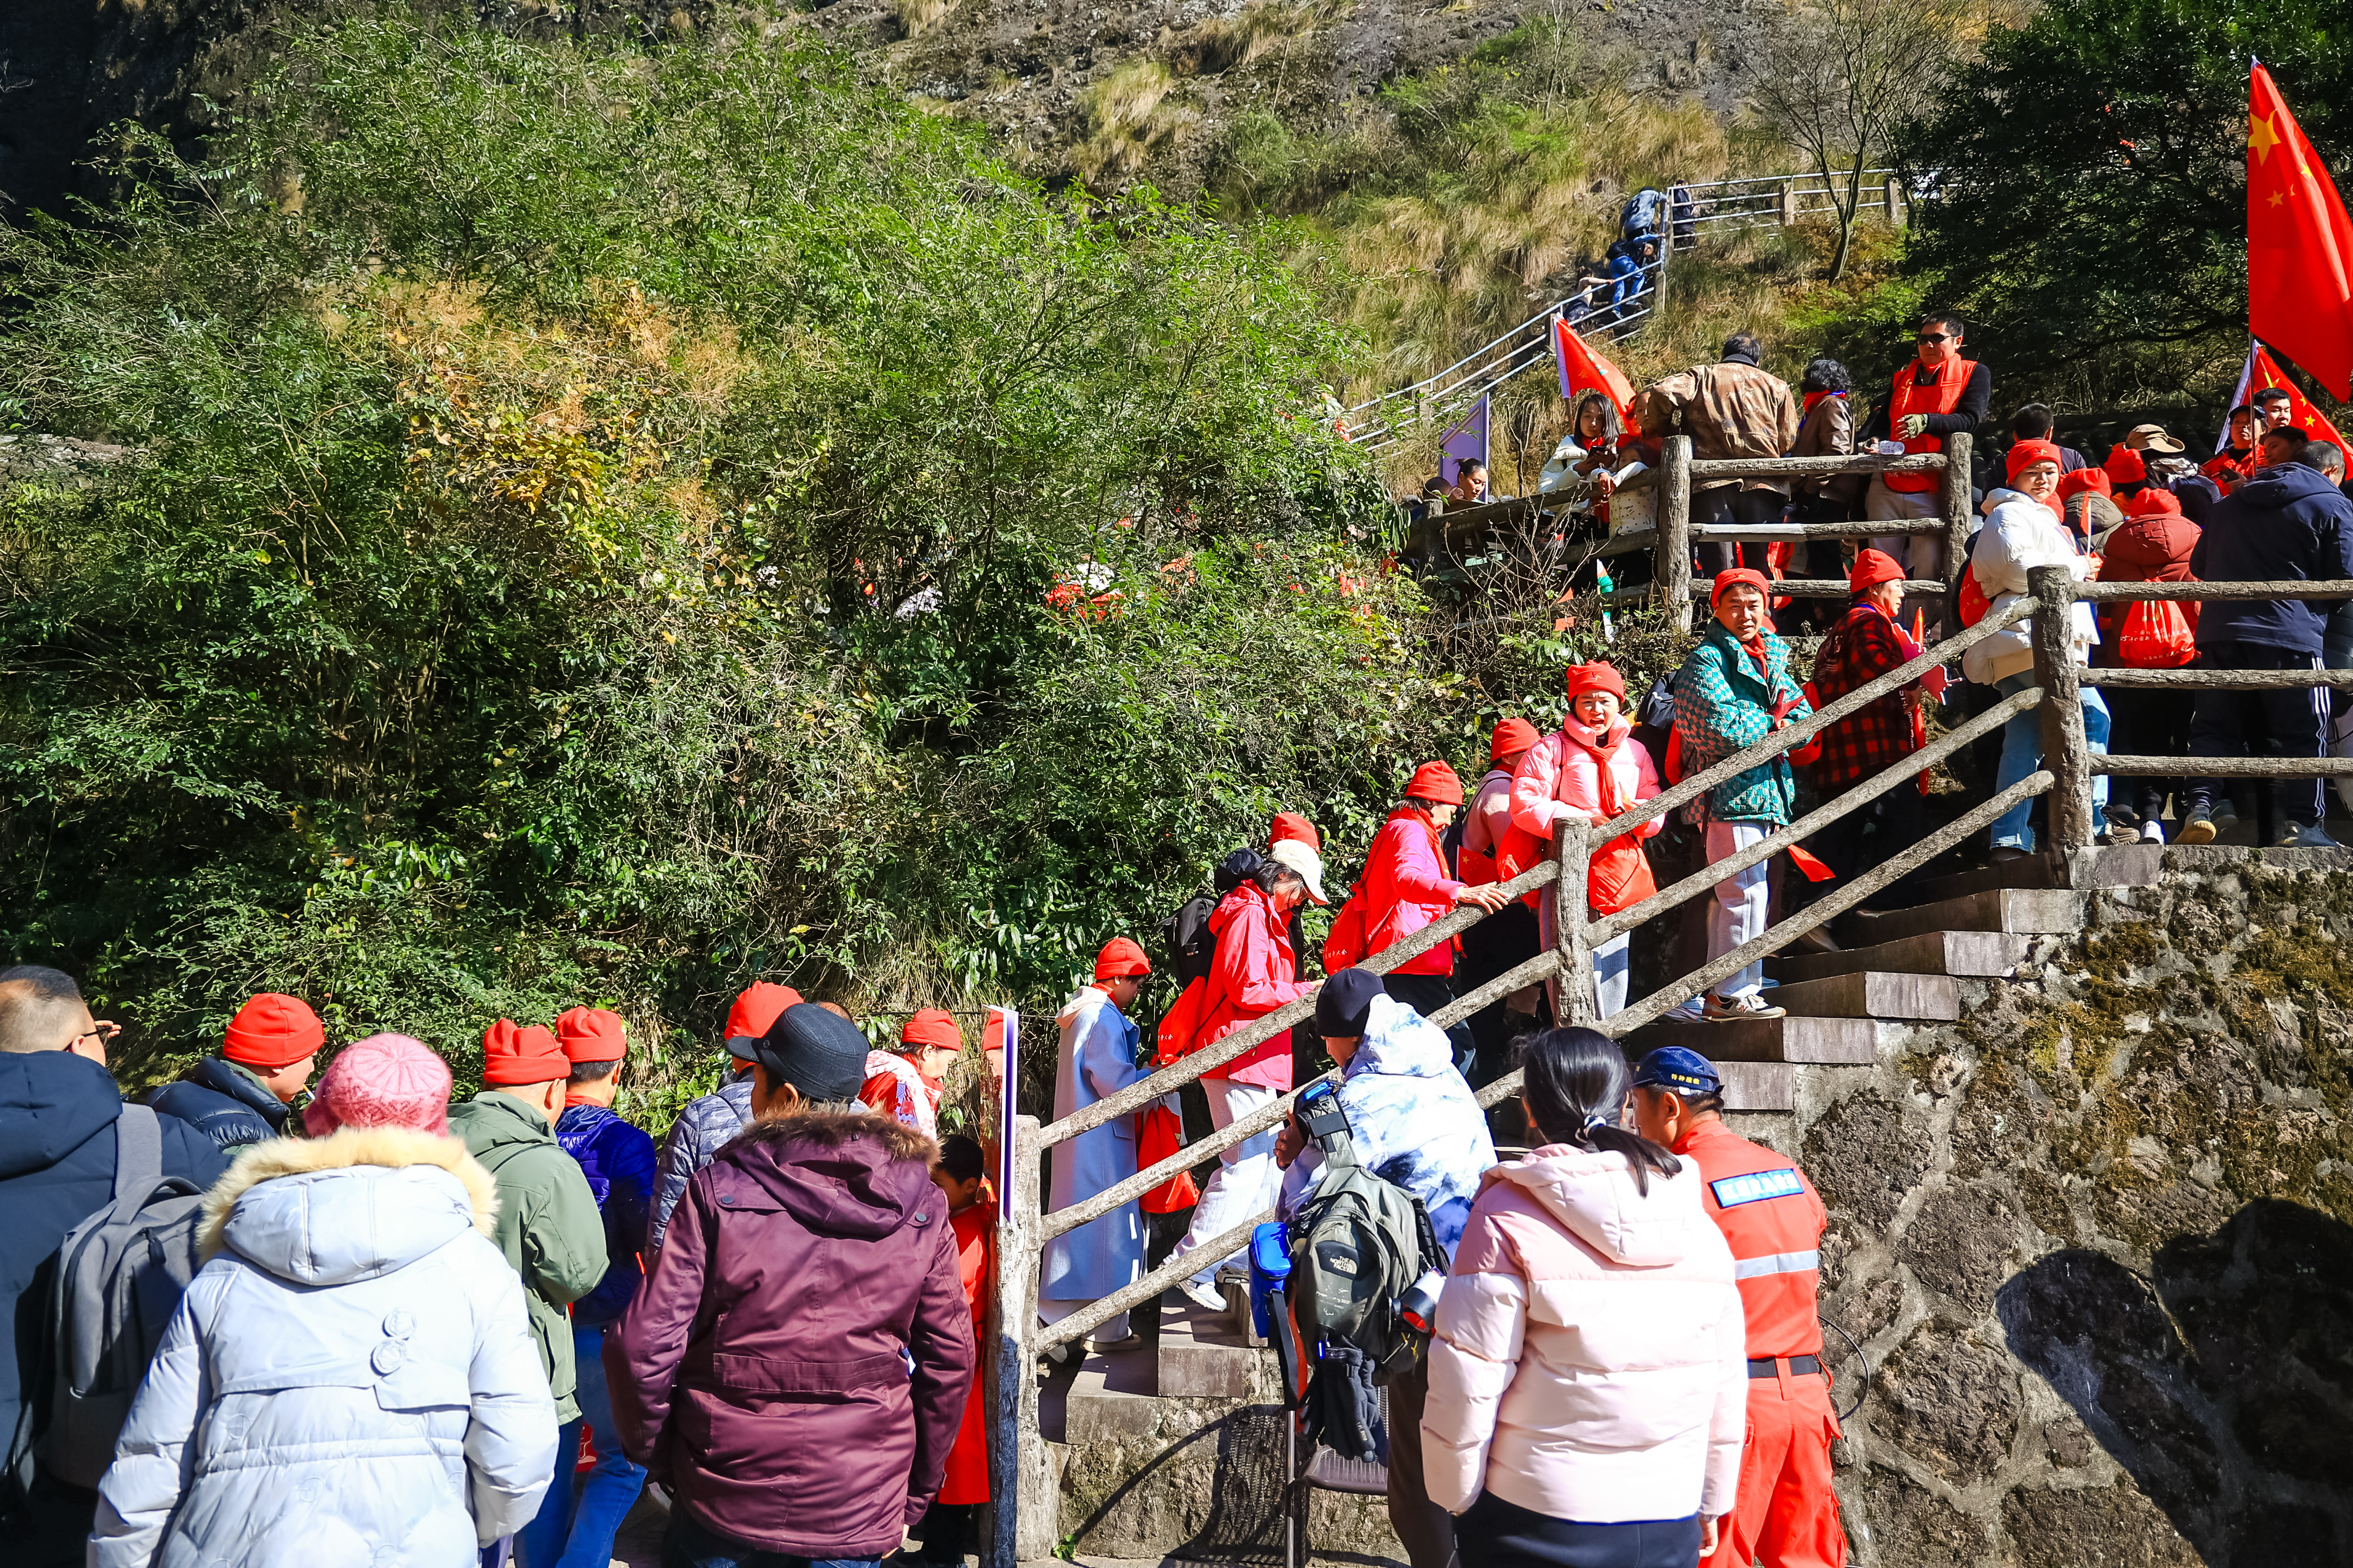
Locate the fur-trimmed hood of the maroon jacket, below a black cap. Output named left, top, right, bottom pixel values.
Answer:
left=713, top=1109, right=941, bottom=1241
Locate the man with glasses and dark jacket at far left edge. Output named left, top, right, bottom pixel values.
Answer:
left=0, top=963, right=228, bottom=1566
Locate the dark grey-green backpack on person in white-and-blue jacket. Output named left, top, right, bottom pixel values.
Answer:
left=1289, top=1095, right=1447, bottom=1368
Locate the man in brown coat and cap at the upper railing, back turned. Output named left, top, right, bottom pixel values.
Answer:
left=1633, top=332, right=1798, bottom=572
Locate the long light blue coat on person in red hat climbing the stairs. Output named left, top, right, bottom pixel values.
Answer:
left=1038, top=986, right=1151, bottom=1302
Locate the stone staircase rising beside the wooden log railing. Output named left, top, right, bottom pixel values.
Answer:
left=1040, top=845, right=2165, bottom=1561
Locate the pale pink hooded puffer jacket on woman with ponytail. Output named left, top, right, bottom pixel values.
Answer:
left=1421, top=1144, right=1748, bottom=1523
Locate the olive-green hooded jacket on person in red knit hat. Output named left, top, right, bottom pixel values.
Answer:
left=449, top=1090, right=609, bottom=1422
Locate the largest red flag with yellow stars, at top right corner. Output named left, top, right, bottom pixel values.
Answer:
left=2247, top=66, right=2353, bottom=398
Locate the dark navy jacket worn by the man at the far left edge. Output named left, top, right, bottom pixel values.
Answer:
left=0, top=1050, right=228, bottom=1516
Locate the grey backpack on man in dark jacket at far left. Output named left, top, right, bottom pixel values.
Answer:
left=40, top=1104, right=205, bottom=1488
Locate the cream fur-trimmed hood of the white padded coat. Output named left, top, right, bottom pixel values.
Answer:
left=198, top=1127, right=499, bottom=1286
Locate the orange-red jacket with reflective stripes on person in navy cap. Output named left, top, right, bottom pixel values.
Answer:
left=1675, top=1120, right=1828, bottom=1361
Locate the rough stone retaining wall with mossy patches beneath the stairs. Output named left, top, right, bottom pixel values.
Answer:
left=1779, top=855, right=2353, bottom=1568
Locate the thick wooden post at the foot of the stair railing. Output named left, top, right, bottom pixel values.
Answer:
left=984, top=1116, right=1061, bottom=1568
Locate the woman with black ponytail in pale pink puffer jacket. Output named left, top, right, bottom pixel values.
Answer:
left=1421, top=1029, right=1748, bottom=1568
